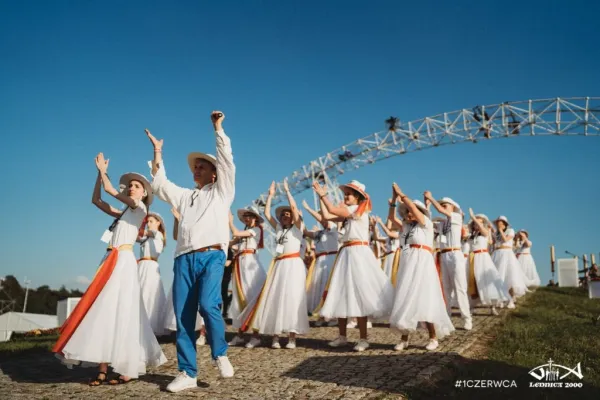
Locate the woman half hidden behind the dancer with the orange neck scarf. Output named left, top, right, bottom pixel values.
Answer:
left=302, top=201, right=339, bottom=326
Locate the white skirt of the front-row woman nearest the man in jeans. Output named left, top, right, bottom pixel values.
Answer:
left=243, top=257, right=310, bottom=335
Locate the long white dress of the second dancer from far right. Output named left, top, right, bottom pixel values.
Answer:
left=492, top=228, right=529, bottom=297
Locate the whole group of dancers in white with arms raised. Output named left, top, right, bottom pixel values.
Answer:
left=53, top=112, right=540, bottom=392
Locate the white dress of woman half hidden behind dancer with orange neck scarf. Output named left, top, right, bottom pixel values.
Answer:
left=306, top=224, right=339, bottom=313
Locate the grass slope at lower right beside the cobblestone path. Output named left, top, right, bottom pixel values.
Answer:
left=407, top=288, right=600, bottom=400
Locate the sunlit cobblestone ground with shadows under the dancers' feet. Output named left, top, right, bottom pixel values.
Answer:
left=0, top=309, right=508, bottom=400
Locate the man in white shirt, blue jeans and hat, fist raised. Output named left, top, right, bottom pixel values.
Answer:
left=146, top=111, right=235, bottom=392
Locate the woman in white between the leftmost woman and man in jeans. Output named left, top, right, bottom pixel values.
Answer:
left=137, top=213, right=167, bottom=336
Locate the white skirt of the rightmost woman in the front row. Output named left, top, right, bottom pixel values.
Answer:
left=390, top=248, right=454, bottom=339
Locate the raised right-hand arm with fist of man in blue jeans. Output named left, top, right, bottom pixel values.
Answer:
left=210, top=111, right=235, bottom=202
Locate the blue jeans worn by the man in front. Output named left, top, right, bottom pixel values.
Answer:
left=173, top=250, right=227, bottom=377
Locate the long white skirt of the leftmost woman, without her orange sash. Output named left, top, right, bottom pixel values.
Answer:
left=62, top=251, right=167, bottom=378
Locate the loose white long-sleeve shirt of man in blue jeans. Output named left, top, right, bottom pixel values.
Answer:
left=152, top=130, right=235, bottom=257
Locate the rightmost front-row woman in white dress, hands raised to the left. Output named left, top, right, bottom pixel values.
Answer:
left=390, top=183, right=454, bottom=351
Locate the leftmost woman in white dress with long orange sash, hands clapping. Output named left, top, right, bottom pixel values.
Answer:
left=52, top=153, right=167, bottom=386
